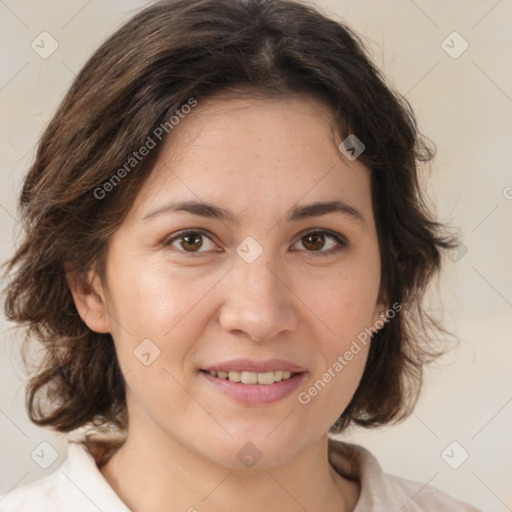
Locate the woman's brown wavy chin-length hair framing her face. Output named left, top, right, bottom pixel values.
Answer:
left=4, top=0, right=455, bottom=440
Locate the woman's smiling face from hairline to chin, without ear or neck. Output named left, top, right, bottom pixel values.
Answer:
left=90, top=96, right=385, bottom=468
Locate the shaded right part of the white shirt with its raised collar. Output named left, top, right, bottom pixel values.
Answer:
left=329, top=438, right=481, bottom=512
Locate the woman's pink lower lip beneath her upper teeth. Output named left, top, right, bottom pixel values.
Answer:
left=200, top=371, right=306, bottom=405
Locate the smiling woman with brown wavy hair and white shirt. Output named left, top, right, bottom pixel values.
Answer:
left=0, top=0, right=476, bottom=512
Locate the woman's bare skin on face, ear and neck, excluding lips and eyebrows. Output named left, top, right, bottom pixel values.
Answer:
left=68, top=95, right=386, bottom=512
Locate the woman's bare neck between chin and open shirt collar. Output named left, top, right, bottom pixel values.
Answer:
left=100, top=431, right=359, bottom=512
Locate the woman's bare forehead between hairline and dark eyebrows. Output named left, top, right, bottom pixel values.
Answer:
left=127, top=95, right=369, bottom=224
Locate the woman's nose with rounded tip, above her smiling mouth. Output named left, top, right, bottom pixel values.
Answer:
left=219, top=255, right=298, bottom=341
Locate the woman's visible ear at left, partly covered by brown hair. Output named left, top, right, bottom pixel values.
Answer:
left=64, top=262, right=110, bottom=333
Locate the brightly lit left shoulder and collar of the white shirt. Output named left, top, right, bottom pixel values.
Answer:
left=0, top=442, right=129, bottom=512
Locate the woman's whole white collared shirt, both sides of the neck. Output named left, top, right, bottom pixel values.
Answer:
left=0, top=437, right=481, bottom=512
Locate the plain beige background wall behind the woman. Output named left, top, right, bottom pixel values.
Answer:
left=0, top=0, right=512, bottom=512
